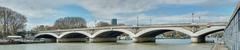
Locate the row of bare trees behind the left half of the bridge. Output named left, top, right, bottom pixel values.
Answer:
left=33, top=17, right=125, bottom=31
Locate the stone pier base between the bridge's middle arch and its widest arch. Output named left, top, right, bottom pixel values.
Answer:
left=133, top=37, right=155, bottom=43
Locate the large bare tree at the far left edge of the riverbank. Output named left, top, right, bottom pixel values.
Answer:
left=0, top=7, right=27, bottom=36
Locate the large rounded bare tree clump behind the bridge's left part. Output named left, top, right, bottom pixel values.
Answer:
left=54, top=17, right=87, bottom=29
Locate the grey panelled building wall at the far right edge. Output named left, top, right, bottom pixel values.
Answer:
left=224, top=4, right=240, bottom=50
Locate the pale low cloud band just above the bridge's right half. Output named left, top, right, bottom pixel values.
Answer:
left=113, top=11, right=229, bottom=25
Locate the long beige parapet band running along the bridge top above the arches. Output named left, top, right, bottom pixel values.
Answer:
left=40, top=22, right=227, bottom=33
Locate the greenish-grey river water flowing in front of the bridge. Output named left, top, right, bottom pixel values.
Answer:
left=0, top=39, right=213, bottom=50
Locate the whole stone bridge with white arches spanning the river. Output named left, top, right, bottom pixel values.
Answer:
left=35, top=23, right=226, bottom=42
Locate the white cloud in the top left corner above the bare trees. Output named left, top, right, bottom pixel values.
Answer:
left=0, top=0, right=71, bottom=18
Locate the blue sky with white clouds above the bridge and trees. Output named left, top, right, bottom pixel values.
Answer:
left=0, top=0, right=238, bottom=29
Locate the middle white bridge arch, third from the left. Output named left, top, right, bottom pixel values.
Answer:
left=91, top=29, right=134, bottom=38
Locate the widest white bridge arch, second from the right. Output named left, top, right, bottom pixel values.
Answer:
left=135, top=28, right=193, bottom=37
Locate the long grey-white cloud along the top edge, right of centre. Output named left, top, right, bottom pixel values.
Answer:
left=75, top=0, right=234, bottom=16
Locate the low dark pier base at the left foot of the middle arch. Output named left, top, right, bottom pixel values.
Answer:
left=88, top=38, right=117, bottom=43
